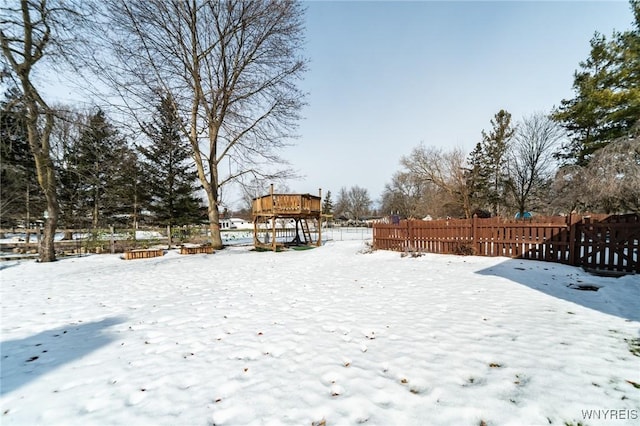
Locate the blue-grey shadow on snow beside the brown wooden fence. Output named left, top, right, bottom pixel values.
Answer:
left=477, top=259, right=640, bottom=321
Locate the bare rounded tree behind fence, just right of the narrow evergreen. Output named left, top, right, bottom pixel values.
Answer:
left=507, top=113, right=563, bottom=217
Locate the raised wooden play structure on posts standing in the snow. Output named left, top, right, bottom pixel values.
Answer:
left=252, top=185, right=322, bottom=251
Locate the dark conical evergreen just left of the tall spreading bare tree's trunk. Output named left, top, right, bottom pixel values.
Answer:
left=139, top=95, right=202, bottom=225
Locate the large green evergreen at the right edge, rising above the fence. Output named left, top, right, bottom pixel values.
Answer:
left=553, top=0, right=640, bottom=166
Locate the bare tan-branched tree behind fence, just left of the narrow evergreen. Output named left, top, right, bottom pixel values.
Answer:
left=400, top=144, right=472, bottom=218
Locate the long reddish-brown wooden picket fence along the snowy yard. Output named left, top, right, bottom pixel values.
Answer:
left=373, top=214, right=640, bottom=272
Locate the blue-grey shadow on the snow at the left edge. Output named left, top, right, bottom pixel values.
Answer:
left=0, top=317, right=124, bottom=396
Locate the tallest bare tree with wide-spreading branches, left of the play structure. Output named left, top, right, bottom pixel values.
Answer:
left=94, top=0, right=306, bottom=247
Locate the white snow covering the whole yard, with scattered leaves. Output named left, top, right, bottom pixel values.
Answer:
left=0, top=238, right=640, bottom=426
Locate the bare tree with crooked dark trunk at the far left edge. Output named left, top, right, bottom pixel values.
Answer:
left=0, top=0, right=77, bottom=262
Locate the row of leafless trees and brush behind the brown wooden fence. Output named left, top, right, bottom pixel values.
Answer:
left=381, top=113, right=640, bottom=218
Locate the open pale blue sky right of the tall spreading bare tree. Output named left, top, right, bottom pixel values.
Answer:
left=284, top=1, right=633, bottom=206
